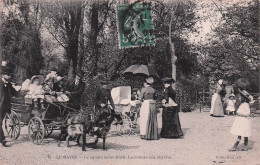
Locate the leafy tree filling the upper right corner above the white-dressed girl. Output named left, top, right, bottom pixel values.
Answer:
left=201, top=0, right=260, bottom=91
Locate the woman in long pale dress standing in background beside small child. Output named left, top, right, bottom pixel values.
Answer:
left=210, top=80, right=224, bottom=117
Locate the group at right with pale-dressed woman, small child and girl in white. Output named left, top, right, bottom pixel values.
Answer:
left=210, top=79, right=254, bottom=151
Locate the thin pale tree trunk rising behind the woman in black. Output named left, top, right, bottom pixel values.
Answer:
left=169, top=14, right=177, bottom=89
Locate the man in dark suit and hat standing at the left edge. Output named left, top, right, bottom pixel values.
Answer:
left=0, top=62, right=18, bottom=147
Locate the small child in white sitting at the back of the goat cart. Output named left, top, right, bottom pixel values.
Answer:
left=25, top=76, right=44, bottom=109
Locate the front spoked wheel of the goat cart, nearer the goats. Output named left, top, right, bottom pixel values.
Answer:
left=28, top=117, right=44, bottom=144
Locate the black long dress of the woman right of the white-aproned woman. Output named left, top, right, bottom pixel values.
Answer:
left=161, top=86, right=183, bottom=138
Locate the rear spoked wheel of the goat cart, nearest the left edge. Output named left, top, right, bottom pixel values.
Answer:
left=5, top=111, right=21, bottom=140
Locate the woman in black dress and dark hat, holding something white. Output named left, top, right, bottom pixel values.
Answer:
left=161, top=77, right=183, bottom=138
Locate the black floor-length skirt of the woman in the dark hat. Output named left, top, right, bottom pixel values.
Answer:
left=161, top=107, right=183, bottom=138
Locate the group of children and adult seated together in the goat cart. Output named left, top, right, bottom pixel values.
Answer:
left=20, top=68, right=85, bottom=110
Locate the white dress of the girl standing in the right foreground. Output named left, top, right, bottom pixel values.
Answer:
left=230, top=103, right=251, bottom=137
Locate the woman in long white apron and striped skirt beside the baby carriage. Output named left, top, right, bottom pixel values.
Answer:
left=139, top=77, right=159, bottom=140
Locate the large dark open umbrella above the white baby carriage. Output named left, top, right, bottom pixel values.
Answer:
left=123, top=65, right=159, bottom=78
